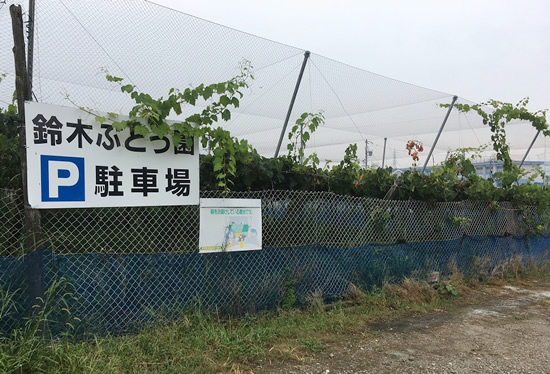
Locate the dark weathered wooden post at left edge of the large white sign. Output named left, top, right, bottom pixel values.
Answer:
left=10, top=5, right=44, bottom=307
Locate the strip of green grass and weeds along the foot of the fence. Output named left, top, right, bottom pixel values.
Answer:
left=0, top=259, right=550, bottom=374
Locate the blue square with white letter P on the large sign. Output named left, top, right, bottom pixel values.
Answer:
left=40, top=155, right=85, bottom=201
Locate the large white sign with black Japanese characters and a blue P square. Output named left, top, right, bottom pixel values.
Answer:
left=25, top=102, right=199, bottom=209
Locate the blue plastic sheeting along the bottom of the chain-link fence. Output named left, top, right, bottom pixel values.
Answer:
left=0, top=236, right=550, bottom=334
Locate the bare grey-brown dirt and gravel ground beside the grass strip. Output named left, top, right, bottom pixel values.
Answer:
left=254, top=282, right=550, bottom=374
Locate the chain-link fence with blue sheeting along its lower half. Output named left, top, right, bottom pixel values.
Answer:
left=0, top=191, right=550, bottom=333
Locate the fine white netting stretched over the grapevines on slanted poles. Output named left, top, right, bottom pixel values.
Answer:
left=0, top=0, right=546, bottom=167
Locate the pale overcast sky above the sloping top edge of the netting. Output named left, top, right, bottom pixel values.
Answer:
left=153, top=0, right=550, bottom=110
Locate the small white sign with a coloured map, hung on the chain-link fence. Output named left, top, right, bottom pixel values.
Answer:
left=199, top=199, right=262, bottom=253
